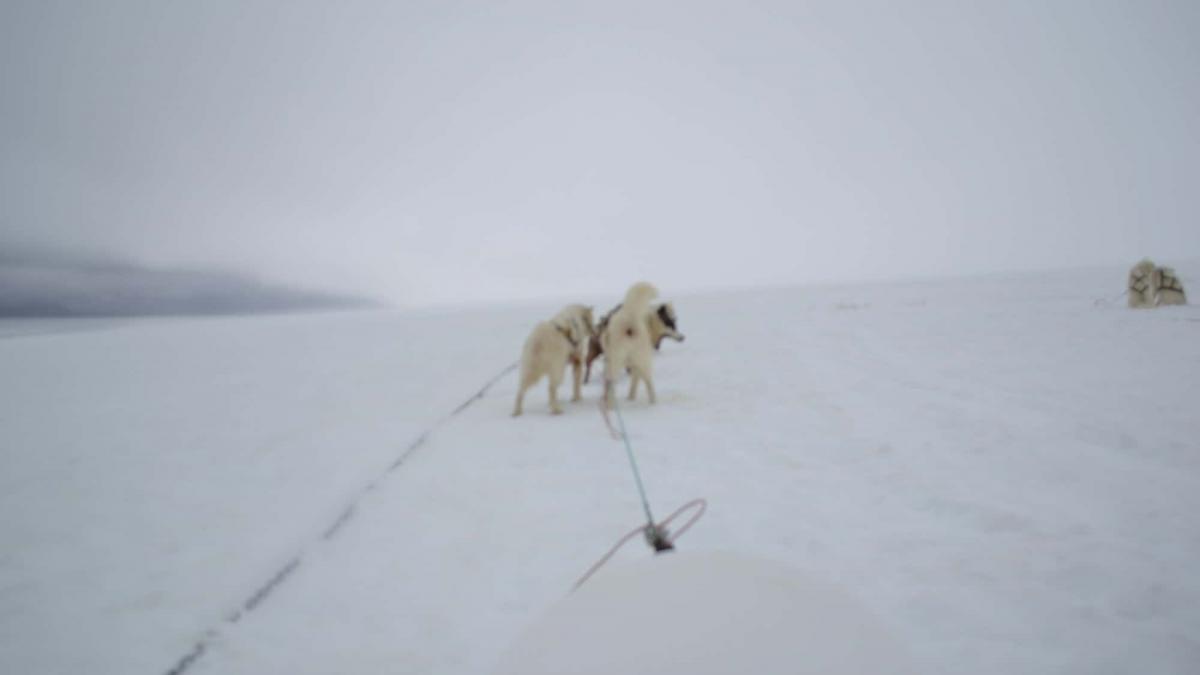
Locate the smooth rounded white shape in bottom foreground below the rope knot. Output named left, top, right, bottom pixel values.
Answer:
left=497, top=552, right=917, bottom=675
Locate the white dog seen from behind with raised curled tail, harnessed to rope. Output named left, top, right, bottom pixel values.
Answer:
left=600, top=281, right=659, bottom=406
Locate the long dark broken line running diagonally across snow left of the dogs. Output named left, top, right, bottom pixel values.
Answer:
left=159, top=363, right=517, bottom=675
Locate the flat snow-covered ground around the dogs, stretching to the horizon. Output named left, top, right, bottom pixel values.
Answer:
left=0, top=265, right=1200, bottom=674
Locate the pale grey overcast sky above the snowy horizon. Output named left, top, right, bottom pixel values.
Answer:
left=0, top=0, right=1200, bottom=305
